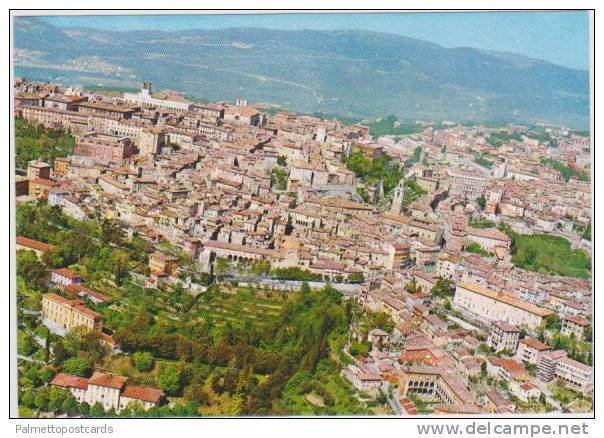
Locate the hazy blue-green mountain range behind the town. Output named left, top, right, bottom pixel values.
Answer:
left=13, top=17, right=589, bottom=129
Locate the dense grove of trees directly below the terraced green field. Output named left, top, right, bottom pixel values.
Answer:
left=114, top=285, right=360, bottom=415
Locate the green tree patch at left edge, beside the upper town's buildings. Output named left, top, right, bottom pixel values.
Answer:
left=15, top=117, right=75, bottom=169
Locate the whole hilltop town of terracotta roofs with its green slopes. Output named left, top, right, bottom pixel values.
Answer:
left=14, top=79, right=594, bottom=416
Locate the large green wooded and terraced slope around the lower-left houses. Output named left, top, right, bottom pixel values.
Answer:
left=17, top=203, right=367, bottom=417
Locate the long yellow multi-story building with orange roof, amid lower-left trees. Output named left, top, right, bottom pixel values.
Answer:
left=42, top=293, right=102, bottom=331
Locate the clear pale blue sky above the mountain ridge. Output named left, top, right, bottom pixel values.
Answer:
left=41, top=11, right=590, bottom=70
